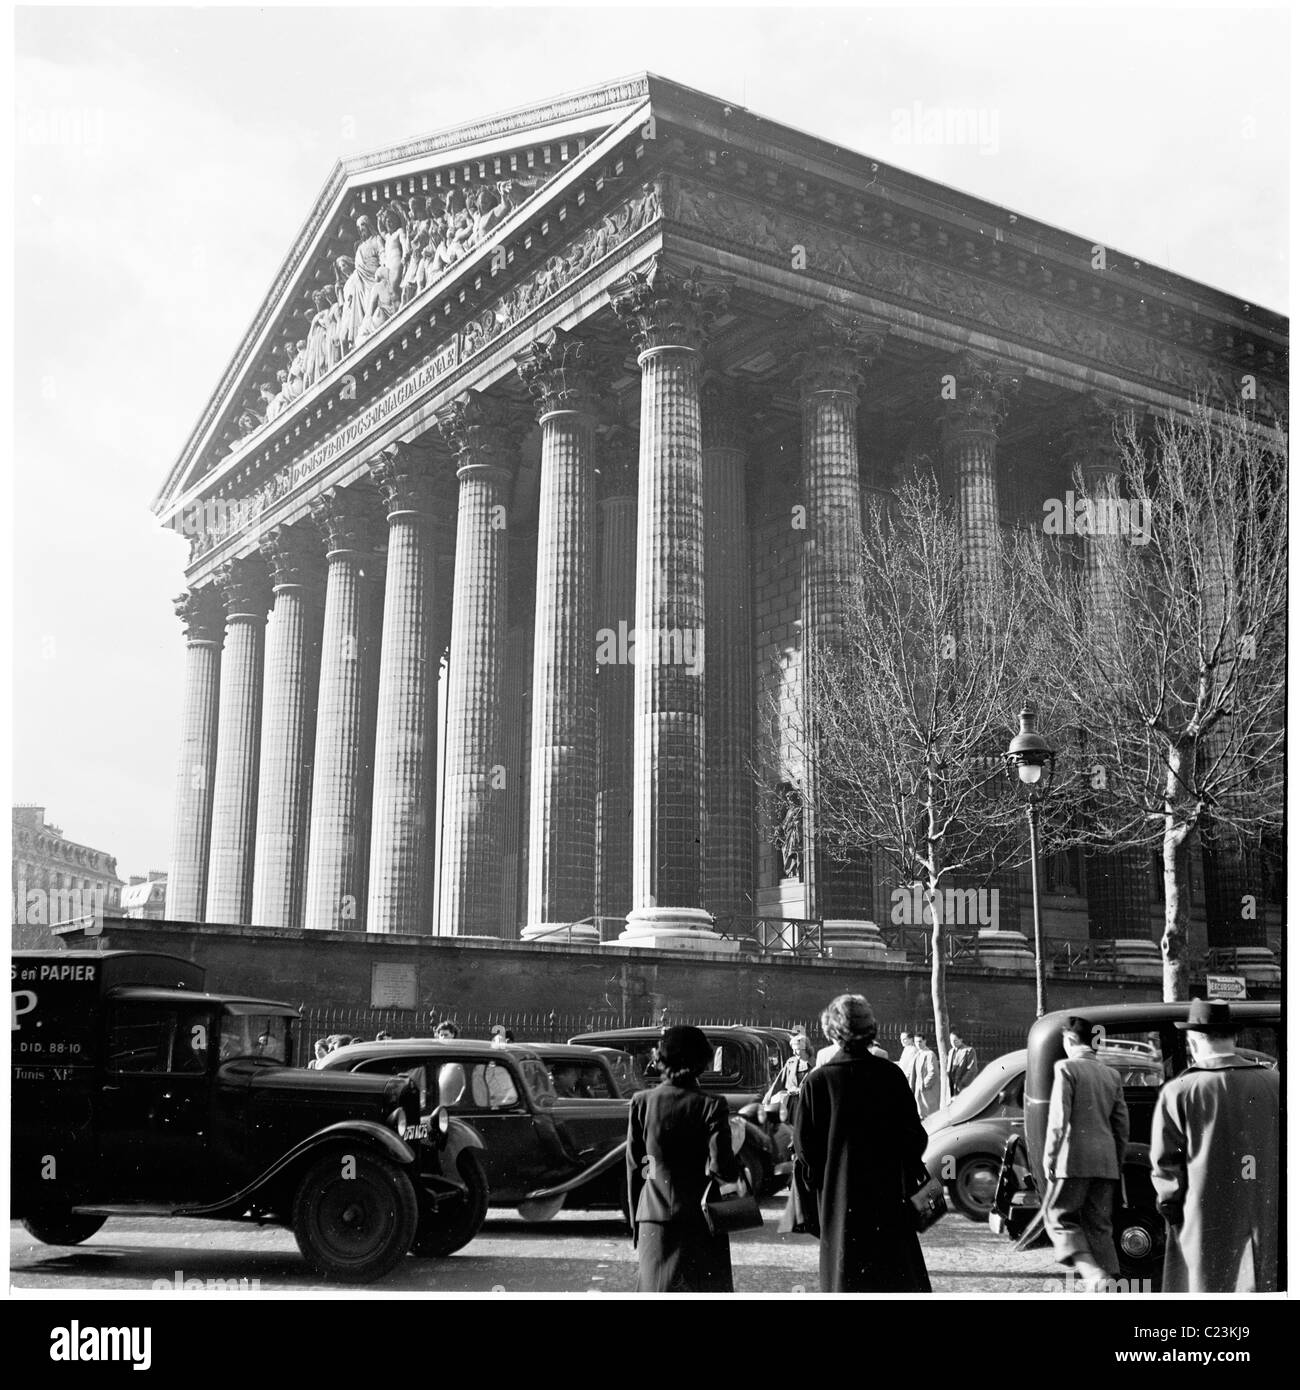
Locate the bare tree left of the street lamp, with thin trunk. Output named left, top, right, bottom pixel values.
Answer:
left=781, top=477, right=1053, bottom=1101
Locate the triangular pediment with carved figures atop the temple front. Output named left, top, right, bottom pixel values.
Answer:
left=154, top=74, right=649, bottom=517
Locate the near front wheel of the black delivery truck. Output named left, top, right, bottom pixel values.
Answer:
left=293, top=1152, right=420, bottom=1284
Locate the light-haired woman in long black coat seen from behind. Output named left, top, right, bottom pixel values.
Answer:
left=794, top=994, right=930, bottom=1293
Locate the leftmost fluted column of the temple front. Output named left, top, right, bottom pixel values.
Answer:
left=163, top=587, right=225, bottom=922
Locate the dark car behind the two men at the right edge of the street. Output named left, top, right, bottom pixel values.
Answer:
left=989, top=1002, right=1282, bottom=1290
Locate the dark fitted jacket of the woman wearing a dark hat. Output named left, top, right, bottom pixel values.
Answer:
left=627, top=1081, right=740, bottom=1222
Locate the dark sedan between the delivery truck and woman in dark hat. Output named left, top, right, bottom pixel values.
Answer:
left=323, top=1038, right=627, bottom=1220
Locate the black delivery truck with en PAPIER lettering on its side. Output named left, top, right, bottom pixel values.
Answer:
left=11, top=951, right=482, bottom=1283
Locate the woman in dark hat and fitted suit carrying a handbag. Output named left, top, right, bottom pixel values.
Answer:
left=627, top=1024, right=741, bottom=1294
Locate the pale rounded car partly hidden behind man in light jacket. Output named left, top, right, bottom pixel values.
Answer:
left=922, top=1044, right=1164, bottom=1222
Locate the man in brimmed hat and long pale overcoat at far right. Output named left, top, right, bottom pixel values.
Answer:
left=1151, top=999, right=1282, bottom=1294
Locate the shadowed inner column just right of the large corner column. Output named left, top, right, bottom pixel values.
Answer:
left=701, top=378, right=755, bottom=920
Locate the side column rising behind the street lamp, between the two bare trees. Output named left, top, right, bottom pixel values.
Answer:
left=941, top=356, right=1033, bottom=970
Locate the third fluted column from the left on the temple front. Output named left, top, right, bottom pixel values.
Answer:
left=253, top=527, right=325, bottom=931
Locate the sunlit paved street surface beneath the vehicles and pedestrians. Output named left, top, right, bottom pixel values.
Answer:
left=10, top=1200, right=1059, bottom=1294
